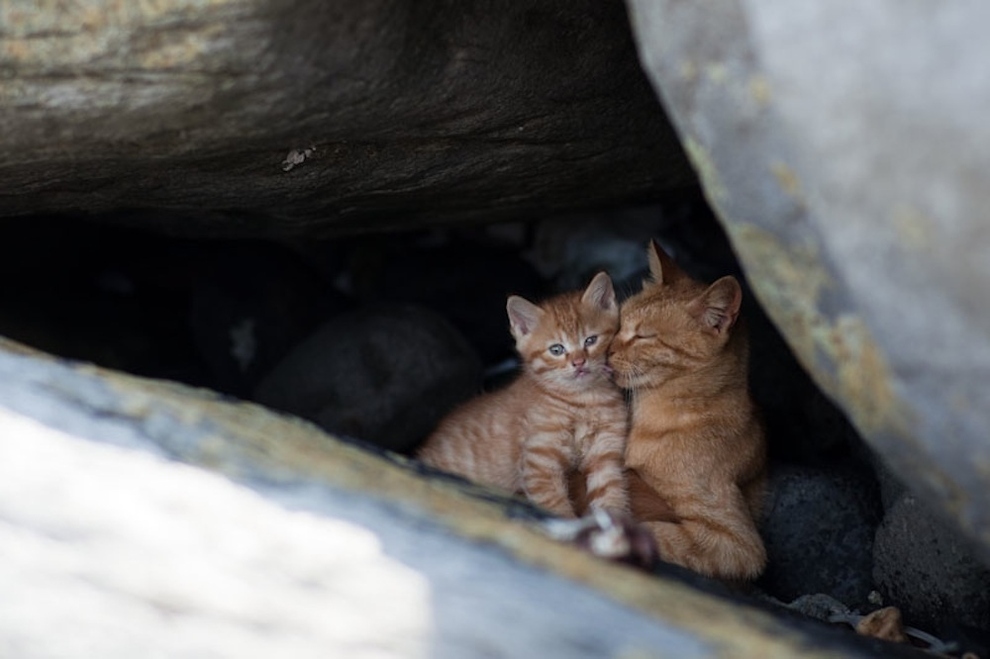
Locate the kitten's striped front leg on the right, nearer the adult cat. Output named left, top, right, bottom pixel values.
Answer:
left=579, top=423, right=629, bottom=513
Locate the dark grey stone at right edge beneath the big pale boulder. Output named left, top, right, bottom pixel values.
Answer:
left=873, top=492, right=990, bottom=630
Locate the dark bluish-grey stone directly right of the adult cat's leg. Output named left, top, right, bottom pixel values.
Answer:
left=759, top=464, right=883, bottom=608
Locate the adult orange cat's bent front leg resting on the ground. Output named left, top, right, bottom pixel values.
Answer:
left=644, top=485, right=767, bottom=581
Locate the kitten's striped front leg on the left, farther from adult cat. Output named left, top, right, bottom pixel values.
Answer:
left=520, top=428, right=575, bottom=517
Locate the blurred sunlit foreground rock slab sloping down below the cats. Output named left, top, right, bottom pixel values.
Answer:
left=0, top=343, right=912, bottom=659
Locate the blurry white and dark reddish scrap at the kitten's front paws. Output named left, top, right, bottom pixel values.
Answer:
left=544, top=509, right=658, bottom=570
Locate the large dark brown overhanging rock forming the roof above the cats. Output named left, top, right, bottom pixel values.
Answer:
left=0, top=0, right=694, bottom=232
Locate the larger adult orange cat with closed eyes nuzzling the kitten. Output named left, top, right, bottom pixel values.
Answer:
left=609, top=243, right=766, bottom=580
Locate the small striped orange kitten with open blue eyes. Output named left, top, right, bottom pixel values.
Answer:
left=416, top=272, right=628, bottom=517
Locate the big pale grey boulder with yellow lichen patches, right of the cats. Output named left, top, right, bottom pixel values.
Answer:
left=628, top=0, right=990, bottom=560
